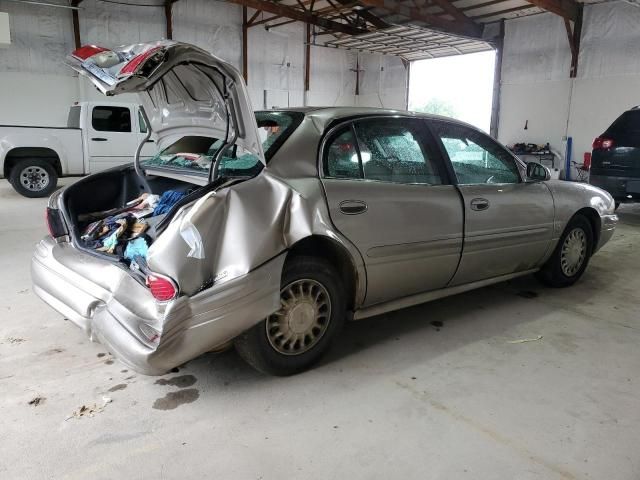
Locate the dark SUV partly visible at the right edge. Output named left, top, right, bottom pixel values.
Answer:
left=589, top=106, right=640, bottom=207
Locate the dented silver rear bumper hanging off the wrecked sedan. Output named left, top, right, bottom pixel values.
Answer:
left=31, top=237, right=286, bottom=375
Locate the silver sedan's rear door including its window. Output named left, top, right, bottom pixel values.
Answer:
left=322, top=117, right=463, bottom=305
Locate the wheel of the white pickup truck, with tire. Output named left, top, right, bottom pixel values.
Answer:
left=9, top=158, right=58, bottom=198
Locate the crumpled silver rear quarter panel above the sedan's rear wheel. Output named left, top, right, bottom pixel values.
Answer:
left=147, top=169, right=363, bottom=302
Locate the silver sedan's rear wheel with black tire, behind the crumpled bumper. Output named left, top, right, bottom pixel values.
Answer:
left=234, top=256, right=346, bottom=376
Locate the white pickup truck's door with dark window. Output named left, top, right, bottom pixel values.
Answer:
left=86, top=105, right=140, bottom=173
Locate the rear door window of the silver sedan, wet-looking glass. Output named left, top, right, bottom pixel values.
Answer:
left=325, top=118, right=442, bottom=185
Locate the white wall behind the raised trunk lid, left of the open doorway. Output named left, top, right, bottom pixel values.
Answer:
left=0, top=0, right=407, bottom=126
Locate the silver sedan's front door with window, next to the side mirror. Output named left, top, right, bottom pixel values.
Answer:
left=429, top=121, right=554, bottom=285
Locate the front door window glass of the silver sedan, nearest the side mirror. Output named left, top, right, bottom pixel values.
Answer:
left=433, top=122, right=520, bottom=185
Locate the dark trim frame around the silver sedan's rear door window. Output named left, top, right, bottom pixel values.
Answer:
left=316, top=114, right=456, bottom=188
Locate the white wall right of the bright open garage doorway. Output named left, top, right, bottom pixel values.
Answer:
left=498, top=2, right=640, bottom=167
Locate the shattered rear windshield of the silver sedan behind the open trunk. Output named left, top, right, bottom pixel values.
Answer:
left=142, top=112, right=303, bottom=177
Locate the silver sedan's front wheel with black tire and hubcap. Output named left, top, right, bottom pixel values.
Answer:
left=536, top=214, right=593, bottom=288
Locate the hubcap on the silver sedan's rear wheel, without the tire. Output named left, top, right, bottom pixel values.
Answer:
left=265, top=279, right=331, bottom=355
